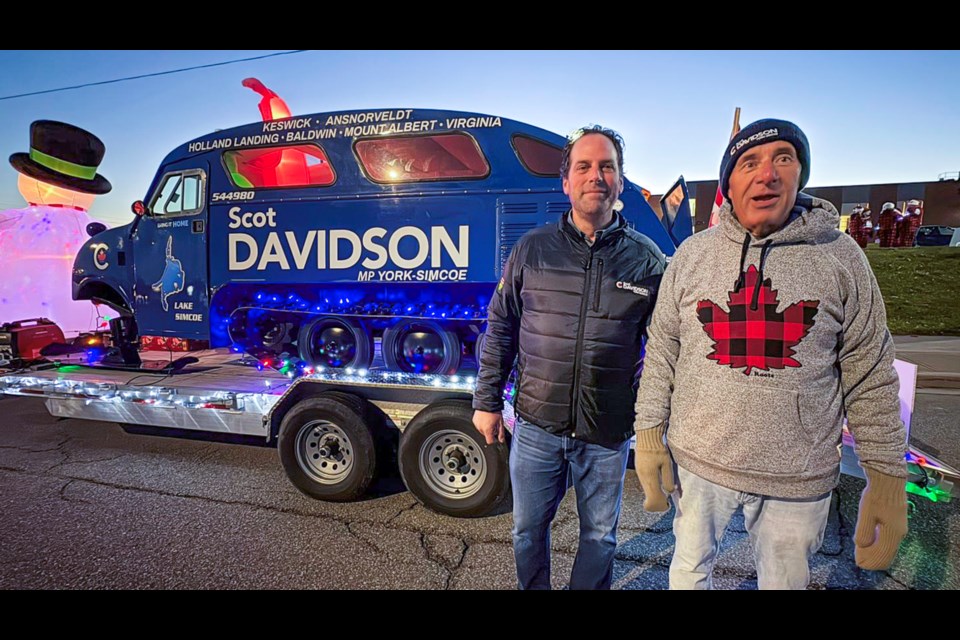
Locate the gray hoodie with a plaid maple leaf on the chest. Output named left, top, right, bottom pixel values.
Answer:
left=635, top=193, right=906, bottom=498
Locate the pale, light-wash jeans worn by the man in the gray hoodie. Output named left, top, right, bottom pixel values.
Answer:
left=670, top=467, right=832, bottom=589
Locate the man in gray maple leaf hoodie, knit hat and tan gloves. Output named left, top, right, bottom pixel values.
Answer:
left=635, top=119, right=907, bottom=589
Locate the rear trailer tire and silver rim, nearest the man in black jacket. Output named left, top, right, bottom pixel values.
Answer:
left=399, top=400, right=510, bottom=518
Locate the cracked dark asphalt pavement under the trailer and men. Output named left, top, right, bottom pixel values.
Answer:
left=0, top=376, right=960, bottom=590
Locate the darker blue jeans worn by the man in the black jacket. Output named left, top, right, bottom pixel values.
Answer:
left=510, top=416, right=630, bottom=589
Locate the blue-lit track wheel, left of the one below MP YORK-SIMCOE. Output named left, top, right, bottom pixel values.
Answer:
left=297, top=316, right=373, bottom=369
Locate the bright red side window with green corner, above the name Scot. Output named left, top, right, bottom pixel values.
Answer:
left=223, top=144, right=337, bottom=189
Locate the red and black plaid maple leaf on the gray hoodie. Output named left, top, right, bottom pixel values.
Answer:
left=697, top=265, right=820, bottom=375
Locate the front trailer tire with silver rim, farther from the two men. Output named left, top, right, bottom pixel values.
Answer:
left=277, top=395, right=377, bottom=502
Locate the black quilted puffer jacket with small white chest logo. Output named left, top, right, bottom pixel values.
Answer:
left=473, top=214, right=665, bottom=447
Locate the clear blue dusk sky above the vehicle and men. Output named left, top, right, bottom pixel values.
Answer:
left=0, top=51, right=960, bottom=226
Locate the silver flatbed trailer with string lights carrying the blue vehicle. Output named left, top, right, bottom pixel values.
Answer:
left=0, top=349, right=960, bottom=517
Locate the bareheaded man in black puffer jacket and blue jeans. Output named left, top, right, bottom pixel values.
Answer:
left=473, top=126, right=664, bottom=589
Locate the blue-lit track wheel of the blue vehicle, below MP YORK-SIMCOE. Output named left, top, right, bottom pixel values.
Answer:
left=382, top=320, right=462, bottom=375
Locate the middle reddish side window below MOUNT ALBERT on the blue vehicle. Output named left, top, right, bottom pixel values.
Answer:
left=354, top=132, right=490, bottom=184
